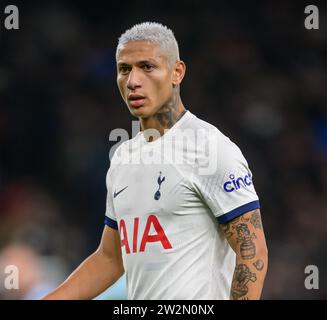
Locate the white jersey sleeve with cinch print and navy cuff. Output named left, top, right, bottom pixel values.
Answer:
left=193, top=133, right=260, bottom=224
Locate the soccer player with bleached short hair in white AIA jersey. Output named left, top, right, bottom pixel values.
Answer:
left=45, top=22, right=268, bottom=300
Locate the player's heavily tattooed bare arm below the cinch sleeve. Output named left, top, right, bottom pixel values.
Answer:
left=220, top=209, right=268, bottom=300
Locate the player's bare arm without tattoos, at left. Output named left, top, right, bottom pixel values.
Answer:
left=43, top=226, right=124, bottom=300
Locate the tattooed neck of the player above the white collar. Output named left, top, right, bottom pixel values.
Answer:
left=140, top=98, right=186, bottom=142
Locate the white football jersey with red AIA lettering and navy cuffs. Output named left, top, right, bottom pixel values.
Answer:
left=105, top=111, right=259, bottom=300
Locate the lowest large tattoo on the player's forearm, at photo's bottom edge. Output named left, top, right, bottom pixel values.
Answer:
left=231, top=264, right=257, bottom=300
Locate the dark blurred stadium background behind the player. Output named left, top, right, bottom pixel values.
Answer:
left=0, top=1, right=327, bottom=299
